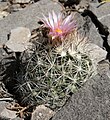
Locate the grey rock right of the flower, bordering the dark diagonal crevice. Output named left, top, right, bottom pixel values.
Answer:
left=74, top=13, right=103, bottom=48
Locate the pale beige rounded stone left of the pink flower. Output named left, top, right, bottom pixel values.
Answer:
left=5, top=27, right=32, bottom=52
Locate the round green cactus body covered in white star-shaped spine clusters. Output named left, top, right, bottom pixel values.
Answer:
left=17, top=35, right=93, bottom=110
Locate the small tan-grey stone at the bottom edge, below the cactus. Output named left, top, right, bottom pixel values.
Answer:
left=31, top=105, right=55, bottom=120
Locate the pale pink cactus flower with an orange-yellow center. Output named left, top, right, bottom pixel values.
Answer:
left=41, top=11, right=76, bottom=40
